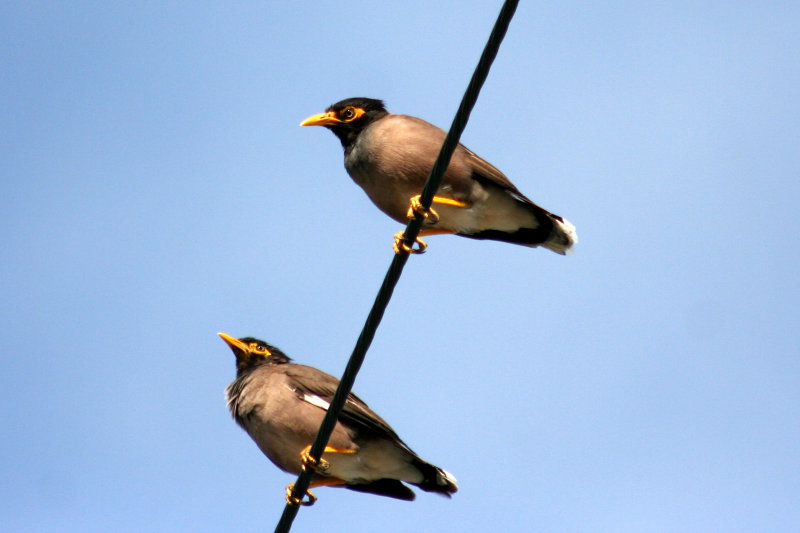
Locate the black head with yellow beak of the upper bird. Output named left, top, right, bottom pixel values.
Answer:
left=300, top=97, right=389, bottom=150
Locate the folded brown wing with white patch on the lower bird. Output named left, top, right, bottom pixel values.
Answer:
left=286, top=365, right=404, bottom=445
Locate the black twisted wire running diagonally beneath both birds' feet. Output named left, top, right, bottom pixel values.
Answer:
left=275, top=0, right=519, bottom=533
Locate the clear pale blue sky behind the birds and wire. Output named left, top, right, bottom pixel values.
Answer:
left=0, top=1, right=800, bottom=532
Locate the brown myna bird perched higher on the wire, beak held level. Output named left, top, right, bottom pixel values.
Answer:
left=300, top=98, right=578, bottom=254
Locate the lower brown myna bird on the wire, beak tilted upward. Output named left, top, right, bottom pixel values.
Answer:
left=219, top=333, right=458, bottom=505
